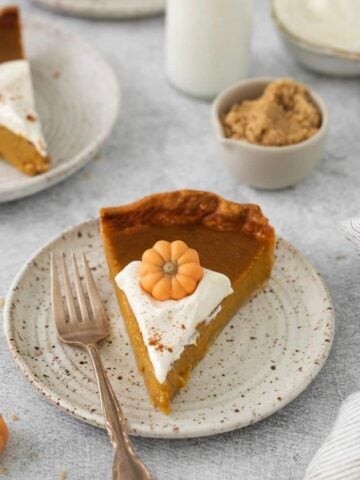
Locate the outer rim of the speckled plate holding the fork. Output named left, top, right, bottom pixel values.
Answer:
left=4, top=219, right=335, bottom=438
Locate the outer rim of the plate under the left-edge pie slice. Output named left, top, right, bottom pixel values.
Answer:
left=0, top=15, right=121, bottom=203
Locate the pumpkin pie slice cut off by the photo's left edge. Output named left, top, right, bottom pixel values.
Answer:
left=0, top=7, right=50, bottom=175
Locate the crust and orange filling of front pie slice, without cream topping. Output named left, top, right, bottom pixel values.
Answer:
left=100, top=190, right=275, bottom=414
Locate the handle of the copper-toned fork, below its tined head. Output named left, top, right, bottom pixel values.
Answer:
left=86, top=344, right=152, bottom=480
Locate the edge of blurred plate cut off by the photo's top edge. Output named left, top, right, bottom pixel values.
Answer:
left=33, top=0, right=165, bottom=18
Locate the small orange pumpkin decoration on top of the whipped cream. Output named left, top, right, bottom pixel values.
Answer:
left=140, top=240, right=203, bottom=300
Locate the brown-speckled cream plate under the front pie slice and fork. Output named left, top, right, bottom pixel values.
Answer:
left=5, top=220, right=334, bottom=438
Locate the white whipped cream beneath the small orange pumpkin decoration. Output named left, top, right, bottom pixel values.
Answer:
left=115, top=261, right=233, bottom=383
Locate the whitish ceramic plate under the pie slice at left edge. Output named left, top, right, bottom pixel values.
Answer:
left=0, top=17, right=119, bottom=202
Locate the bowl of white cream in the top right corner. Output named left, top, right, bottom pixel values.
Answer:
left=272, top=0, right=360, bottom=76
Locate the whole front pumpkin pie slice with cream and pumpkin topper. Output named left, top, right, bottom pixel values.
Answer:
left=100, top=190, right=275, bottom=413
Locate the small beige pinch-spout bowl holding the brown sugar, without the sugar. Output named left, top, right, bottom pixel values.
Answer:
left=212, top=78, right=328, bottom=189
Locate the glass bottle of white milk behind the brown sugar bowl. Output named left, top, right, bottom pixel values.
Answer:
left=166, top=0, right=252, bottom=99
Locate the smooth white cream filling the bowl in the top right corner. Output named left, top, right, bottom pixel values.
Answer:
left=274, top=0, right=360, bottom=52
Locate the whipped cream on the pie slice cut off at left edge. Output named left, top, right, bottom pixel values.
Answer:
left=0, top=60, right=47, bottom=157
